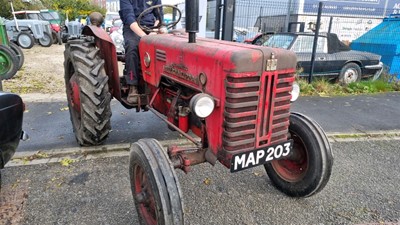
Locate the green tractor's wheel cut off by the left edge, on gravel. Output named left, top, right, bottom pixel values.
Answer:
left=0, top=45, right=18, bottom=80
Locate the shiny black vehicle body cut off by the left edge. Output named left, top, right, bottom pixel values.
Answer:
left=0, top=92, right=24, bottom=189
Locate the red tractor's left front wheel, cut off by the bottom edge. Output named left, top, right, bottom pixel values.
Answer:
left=129, top=139, right=184, bottom=225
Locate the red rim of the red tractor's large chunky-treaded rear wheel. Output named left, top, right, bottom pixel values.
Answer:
left=67, top=75, right=81, bottom=128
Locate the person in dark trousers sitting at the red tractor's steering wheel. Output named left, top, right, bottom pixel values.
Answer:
left=119, top=0, right=163, bottom=104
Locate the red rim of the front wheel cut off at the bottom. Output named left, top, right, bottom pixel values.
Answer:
left=134, top=165, right=157, bottom=225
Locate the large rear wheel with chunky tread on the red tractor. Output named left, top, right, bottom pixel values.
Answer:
left=64, top=39, right=111, bottom=146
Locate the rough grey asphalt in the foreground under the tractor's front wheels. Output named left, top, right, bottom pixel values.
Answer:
left=0, top=139, right=400, bottom=225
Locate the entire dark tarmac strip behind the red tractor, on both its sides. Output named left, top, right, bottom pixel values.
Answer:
left=18, top=93, right=400, bottom=152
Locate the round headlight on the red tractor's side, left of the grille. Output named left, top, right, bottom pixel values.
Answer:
left=190, top=93, right=215, bottom=119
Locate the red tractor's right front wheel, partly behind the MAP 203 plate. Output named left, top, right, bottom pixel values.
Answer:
left=264, top=113, right=333, bottom=197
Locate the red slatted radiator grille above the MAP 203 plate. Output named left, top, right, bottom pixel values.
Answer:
left=223, top=74, right=294, bottom=151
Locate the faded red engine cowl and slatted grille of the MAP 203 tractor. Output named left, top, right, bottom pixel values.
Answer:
left=139, top=34, right=297, bottom=167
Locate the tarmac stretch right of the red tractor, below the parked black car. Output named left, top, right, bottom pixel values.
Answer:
left=292, top=93, right=400, bottom=133
